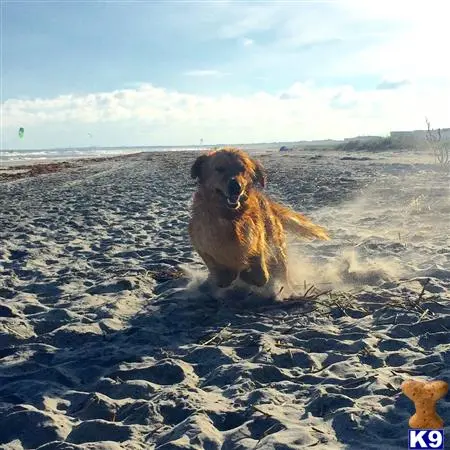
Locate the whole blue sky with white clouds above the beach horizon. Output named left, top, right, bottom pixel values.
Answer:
left=1, top=0, right=450, bottom=148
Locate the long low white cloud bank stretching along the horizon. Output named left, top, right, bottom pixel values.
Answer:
left=2, top=82, right=450, bottom=148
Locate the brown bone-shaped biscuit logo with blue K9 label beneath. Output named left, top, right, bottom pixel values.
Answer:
left=402, top=380, right=448, bottom=450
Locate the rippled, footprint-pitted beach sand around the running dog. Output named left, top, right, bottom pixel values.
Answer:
left=0, top=151, right=450, bottom=450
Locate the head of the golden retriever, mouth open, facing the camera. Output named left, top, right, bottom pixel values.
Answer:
left=191, top=149, right=266, bottom=210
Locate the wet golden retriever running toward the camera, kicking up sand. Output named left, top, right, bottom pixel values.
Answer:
left=189, top=148, right=329, bottom=288
